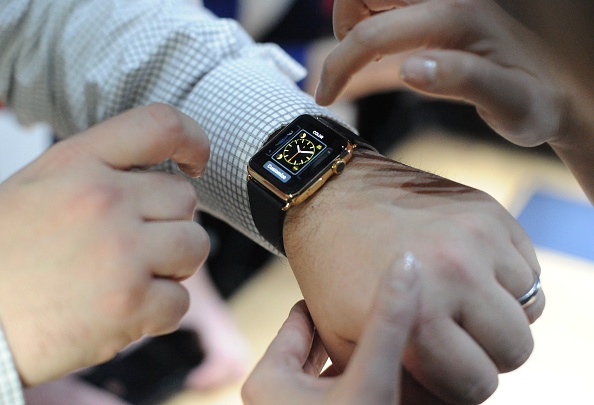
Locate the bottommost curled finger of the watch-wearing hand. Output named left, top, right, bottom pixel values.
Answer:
left=404, top=318, right=498, bottom=404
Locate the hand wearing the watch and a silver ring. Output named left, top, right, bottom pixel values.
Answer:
left=283, top=151, right=544, bottom=404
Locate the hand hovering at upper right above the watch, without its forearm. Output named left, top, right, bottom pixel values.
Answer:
left=316, top=0, right=572, bottom=146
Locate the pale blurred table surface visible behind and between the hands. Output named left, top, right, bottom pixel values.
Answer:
left=166, top=131, right=594, bottom=405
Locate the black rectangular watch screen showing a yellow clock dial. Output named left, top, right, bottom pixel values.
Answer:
left=249, top=116, right=350, bottom=195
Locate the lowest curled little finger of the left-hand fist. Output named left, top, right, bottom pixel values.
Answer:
left=138, top=278, right=190, bottom=335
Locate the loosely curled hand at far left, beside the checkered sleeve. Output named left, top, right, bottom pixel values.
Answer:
left=0, top=104, right=209, bottom=385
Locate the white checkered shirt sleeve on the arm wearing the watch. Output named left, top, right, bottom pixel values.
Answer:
left=0, top=0, right=332, bottom=249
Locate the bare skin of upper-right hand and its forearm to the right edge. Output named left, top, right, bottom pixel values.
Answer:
left=316, top=0, right=594, bottom=202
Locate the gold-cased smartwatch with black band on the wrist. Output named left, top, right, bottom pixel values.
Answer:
left=247, top=115, right=375, bottom=254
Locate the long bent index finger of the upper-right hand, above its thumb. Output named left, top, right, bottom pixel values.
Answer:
left=316, top=1, right=494, bottom=105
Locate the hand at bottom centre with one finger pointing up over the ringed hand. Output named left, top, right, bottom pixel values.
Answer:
left=242, top=255, right=421, bottom=405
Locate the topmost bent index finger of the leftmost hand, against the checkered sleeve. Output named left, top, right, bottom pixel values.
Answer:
left=78, top=104, right=210, bottom=177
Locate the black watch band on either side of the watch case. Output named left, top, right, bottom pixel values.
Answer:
left=247, top=116, right=376, bottom=256
